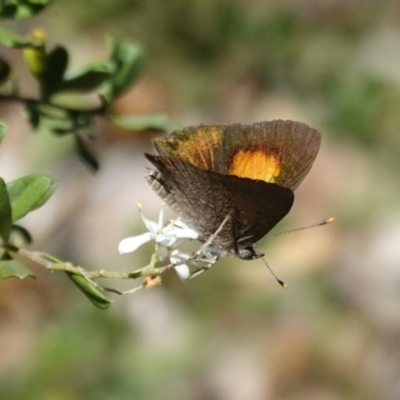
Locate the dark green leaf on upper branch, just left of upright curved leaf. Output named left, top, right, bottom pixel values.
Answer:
left=60, top=62, right=111, bottom=92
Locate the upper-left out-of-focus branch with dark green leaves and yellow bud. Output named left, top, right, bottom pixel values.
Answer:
left=0, top=0, right=174, bottom=170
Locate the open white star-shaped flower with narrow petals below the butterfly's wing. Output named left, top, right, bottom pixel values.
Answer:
left=118, top=204, right=199, bottom=261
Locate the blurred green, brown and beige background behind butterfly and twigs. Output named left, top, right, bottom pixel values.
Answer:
left=0, top=0, right=400, bottom=400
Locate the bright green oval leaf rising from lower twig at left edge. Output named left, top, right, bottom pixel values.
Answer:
left=7, top=174, right=58, bottom=222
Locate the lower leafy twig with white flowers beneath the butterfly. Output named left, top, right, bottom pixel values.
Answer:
left=0, top=158, right=214, bottom=309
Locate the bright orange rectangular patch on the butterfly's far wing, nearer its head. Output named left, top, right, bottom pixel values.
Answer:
left=229, top=150, right=281, bottom=182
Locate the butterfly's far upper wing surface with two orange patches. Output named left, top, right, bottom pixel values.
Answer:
left=154, top=120, right=321, bottom=190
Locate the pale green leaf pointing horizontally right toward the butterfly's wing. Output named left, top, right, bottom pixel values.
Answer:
left=108, top=113, right=179, bottom=132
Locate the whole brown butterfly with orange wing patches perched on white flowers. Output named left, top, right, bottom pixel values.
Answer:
left=145, top=120, right=321, bottom=260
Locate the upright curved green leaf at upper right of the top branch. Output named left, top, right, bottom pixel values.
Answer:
left=102, top=37, right=144, bottom=102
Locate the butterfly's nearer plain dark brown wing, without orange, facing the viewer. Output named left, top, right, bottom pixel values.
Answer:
left=146, top=154, right=293, bottom=253
